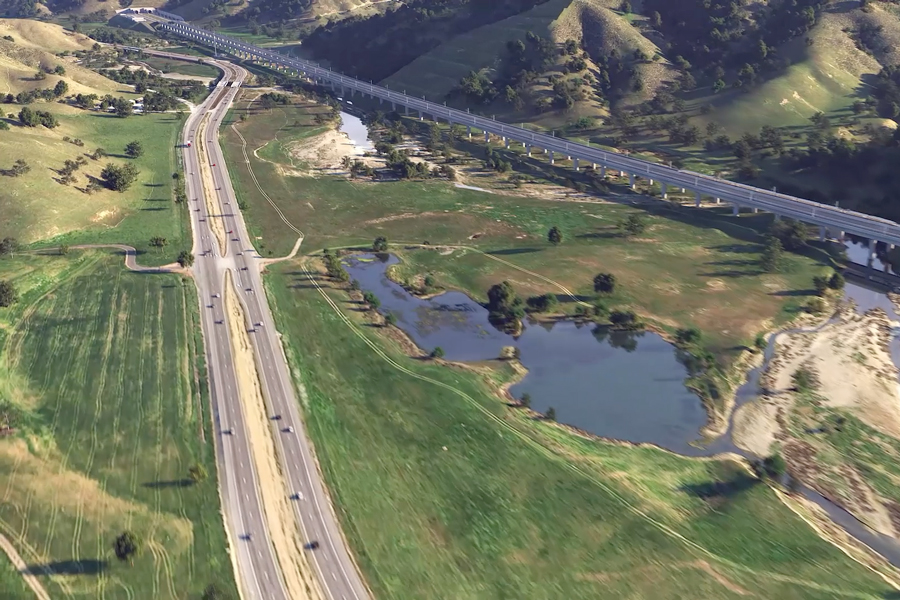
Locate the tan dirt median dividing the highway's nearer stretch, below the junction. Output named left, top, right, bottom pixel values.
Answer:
left=225, top=273, right=323, bottom=600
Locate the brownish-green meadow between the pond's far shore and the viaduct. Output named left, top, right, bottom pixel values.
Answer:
left=225, top=99, right=821, bottom=355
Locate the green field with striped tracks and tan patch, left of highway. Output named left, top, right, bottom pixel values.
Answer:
left=0, top=252, right=234, bottom=600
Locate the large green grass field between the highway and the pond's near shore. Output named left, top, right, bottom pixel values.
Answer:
left=266, top=263, right=890, bottom=600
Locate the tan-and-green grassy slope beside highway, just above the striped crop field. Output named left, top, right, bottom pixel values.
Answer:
left=0, top=104, right=190, bottom=264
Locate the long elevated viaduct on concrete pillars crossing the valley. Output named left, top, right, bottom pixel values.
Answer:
left=156, top=18, right=900, bottom=255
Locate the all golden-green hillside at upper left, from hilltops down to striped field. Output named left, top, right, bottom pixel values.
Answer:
left=0, top=20, right=189, bottom=262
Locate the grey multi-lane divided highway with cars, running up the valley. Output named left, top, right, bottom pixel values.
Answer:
left=166, top=51, right=369, bottom=600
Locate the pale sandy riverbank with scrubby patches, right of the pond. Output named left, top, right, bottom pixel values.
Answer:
left=733, top=305, right=900, bottom=537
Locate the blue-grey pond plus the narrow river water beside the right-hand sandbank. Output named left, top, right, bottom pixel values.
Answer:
left=345, top=252, right=900, bottom=567
